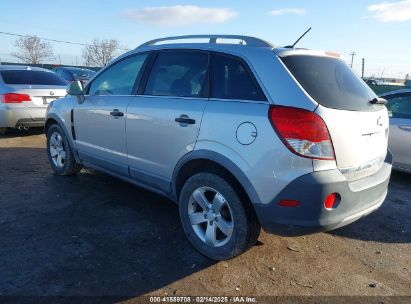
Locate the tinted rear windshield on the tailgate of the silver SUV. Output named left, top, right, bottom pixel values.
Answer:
left=282, top=55, right=381, bottom=111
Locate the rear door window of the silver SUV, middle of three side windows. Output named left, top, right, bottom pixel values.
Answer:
left=144, top=51, right=208, bottom=97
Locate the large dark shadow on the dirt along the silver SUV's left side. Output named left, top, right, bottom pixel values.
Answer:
left=0, top=148, right=214, bottom=298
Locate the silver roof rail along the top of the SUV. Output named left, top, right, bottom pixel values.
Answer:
left=138, top=35, right=274, bottom=48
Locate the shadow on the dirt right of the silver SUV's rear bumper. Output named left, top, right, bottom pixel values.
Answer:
left=329, top=171, right=411, bottom=243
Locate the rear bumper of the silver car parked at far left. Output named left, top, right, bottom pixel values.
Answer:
left=0, top=107, right=46, bottom=128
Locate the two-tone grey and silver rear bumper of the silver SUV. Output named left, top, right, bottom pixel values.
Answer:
left=254, top=152, right=392, bottom=235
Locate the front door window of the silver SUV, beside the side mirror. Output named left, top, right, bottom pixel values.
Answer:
left=88, top=54, right=147, bottom=95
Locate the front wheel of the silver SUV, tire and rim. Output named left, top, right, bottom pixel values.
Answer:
left=47, top=124, right=81, bottom=175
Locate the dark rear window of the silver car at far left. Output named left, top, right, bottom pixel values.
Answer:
left=0, top=70, right=67, bottom=86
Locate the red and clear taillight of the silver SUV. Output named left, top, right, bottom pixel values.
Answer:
left=268, top=106, right=335, bottom=160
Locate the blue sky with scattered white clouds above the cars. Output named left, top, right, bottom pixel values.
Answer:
left=0, top=0, right=411, bottom=78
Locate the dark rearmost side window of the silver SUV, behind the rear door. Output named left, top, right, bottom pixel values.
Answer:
left=211, top=54, right=266, bottom=101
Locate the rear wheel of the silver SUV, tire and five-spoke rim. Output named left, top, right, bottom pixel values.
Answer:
left=179, top=172, right=261, bottom=260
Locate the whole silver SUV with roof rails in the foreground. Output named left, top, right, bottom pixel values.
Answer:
left=46, top=35, right=392, bottom=260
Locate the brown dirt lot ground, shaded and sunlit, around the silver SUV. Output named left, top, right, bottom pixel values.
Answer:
left=0, top=132, right=411, bottom=299
